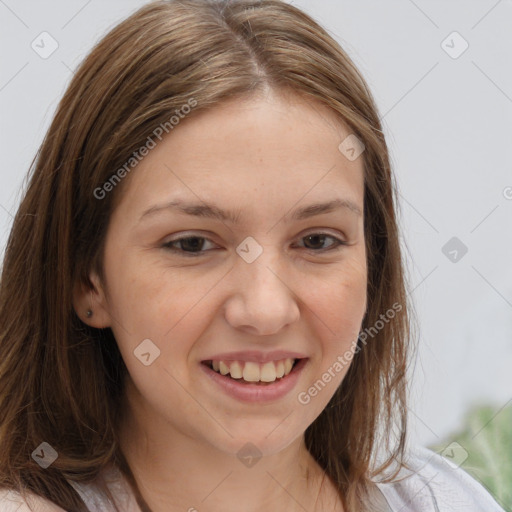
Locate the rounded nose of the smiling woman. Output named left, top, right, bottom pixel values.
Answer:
left=225, top=257, right=300, bottom=336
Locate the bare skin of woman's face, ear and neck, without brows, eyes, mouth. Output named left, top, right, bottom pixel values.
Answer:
left=75, top=92, right=367, bottom=512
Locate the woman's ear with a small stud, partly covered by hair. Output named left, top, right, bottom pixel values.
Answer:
left=73, top=272, right=111, bottom=329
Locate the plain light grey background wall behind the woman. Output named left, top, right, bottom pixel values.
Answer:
left=0, top=0, right=512, bottom=444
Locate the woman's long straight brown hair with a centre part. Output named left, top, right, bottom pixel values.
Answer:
left=0, top=0, right=416, bottom=511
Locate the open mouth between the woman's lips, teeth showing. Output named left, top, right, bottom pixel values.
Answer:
left=201, top=358, right=307, bottom=386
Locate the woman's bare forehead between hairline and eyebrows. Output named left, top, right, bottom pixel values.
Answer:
left=114, top=94, right=364, bottom=222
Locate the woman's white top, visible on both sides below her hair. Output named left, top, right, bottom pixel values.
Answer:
left=0, top=446, right=505, bottom=512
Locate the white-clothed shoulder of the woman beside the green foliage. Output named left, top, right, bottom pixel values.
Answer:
left=377, top=446, right=504, bottom=512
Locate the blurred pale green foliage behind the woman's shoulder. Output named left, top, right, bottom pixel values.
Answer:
left=429, top=405, right=512, bottom=512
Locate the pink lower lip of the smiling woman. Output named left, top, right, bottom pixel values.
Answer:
left=199, top=359, right=308, bottom=403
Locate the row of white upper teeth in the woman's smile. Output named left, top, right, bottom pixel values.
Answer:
left=207, top=358, right=295, bottom=382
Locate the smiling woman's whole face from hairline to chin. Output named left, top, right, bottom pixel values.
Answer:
left=81, top=90, right=367, bottom=454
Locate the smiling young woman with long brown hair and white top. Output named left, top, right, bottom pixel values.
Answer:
left=0, top=0, right=500, bottom=512
